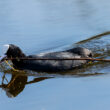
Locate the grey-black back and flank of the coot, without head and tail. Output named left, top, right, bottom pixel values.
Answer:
left=21, top=51, right=87, bottom=71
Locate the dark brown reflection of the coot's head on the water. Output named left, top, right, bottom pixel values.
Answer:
left=0, top=75, right=27, bottom=98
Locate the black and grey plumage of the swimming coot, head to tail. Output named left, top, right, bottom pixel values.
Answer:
left=0, top=44, right=92, bottom=72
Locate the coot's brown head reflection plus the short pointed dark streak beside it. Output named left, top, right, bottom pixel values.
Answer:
left=0, top=74, right=49, bottom=98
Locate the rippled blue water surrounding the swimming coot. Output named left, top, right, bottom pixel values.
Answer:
left=0, top=0, right=110, bottom=110
